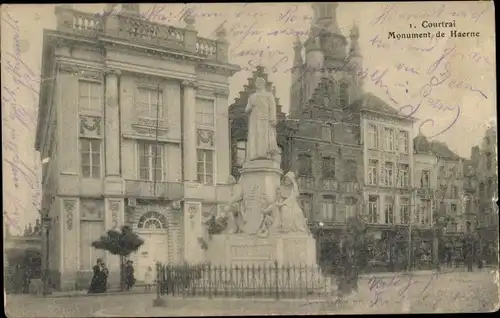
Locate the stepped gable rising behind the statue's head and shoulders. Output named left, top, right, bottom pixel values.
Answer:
left=229, top=66, right=285, bottom=122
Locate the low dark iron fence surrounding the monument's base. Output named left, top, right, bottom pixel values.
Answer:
left=157, top=262, right=336, bottom=299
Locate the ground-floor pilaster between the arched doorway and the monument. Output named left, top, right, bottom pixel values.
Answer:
left=183, top=202, right=203, bottom=264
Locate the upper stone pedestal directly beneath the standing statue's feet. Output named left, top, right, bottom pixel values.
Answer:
left=239, top=160, right=282, bottom=234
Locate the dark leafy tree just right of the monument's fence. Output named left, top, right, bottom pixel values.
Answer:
left=333, top=217, right=369, bottom=297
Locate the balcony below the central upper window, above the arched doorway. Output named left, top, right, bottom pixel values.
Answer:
left=125, top=180, right=184, bottom=200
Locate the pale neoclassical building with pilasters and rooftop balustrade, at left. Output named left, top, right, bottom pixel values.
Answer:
left=35, top=4, right=237, bottom=289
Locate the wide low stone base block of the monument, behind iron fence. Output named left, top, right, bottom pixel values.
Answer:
left=207, top=233, right=316, bottom=267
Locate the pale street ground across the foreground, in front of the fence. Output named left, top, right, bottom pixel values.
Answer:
left=6, top=271, right=499, bottom=317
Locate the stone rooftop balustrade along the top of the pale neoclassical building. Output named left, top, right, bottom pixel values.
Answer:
left=56, top=6, right=228, bottom=62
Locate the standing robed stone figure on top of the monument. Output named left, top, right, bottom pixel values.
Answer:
left=245, top=77, right=279, bottom=161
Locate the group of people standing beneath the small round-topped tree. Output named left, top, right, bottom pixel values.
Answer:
left=88, top=258, right=153, bottom=294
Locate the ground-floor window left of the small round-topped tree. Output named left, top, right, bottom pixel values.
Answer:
left=79, top=220, right=106, bottom=271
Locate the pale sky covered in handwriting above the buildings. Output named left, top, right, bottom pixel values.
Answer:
left=1, top=1, right=496, bottom=233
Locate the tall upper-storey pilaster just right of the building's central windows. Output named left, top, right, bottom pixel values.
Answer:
left=182, top=81, right=197, bottom=182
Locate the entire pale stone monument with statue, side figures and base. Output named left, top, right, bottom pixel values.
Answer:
left=207, top=77, right=316, bottom=266
